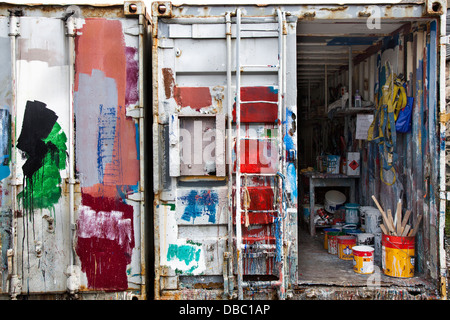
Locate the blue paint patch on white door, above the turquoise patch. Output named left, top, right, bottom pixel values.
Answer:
left=178, top=190, right=219, bottom=223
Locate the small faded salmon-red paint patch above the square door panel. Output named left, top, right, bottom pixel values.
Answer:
left=174, top=87, right=212, bottom=111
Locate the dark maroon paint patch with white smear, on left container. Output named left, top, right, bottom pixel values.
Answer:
left=76, top=194, right=135, bottom=291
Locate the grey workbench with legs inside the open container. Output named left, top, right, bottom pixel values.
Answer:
left=300, top=172, right=359, bottom=236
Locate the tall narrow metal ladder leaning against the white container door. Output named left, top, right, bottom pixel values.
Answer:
left=235, top=8, right=286, bottom=300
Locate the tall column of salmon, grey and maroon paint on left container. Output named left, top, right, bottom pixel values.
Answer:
left=75, top=19, right=139, bottom=291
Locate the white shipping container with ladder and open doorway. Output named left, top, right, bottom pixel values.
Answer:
left=152, top=0, right=447, bottom=300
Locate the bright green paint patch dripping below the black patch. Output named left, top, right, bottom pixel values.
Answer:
left=18, top=122, right=67, bottom=214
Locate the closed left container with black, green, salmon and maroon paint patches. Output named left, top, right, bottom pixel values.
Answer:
left=0, top=2, right=149, bottom=299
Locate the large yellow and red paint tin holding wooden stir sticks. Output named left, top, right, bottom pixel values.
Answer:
left=381, top=234, right=415, bottom=278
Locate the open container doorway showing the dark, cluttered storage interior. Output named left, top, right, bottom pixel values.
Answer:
left=297, top=19, right=438, bottom=288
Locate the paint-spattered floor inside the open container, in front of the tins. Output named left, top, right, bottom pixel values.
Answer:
left=299, top=230, right=430, bottom=287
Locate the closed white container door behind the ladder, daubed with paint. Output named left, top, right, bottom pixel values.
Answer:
left=152, top=3, right=297, bottom=298
